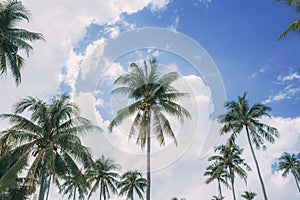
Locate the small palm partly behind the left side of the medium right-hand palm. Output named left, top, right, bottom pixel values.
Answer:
left=204, top=162, right=229, bottom=197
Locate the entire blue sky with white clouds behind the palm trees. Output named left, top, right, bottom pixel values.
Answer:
left=0, top=0, right=300, bottom=200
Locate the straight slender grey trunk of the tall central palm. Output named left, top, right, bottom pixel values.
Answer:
left=146, top=112, right=151, bottom=200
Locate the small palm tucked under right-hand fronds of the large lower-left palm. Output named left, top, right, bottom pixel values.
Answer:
left=59, top=170, right=88, bottom=200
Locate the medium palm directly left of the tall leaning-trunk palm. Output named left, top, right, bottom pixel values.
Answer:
left=208, top=144, right=251, bottom=200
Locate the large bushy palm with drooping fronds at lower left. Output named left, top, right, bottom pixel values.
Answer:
left=0, top=94, right=100, bottom=200
